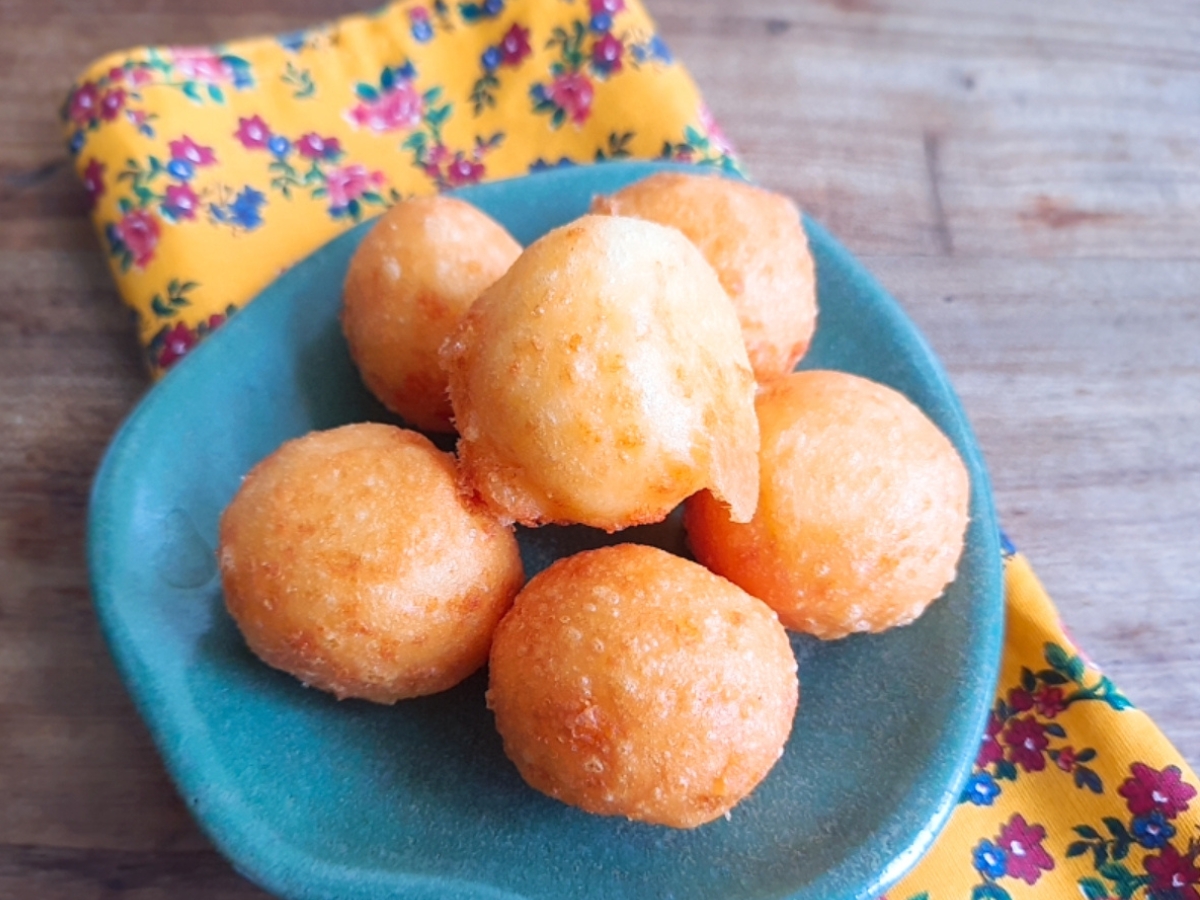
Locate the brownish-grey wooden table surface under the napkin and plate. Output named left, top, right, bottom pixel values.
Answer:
left=0, top=0, right=1200, bottom=900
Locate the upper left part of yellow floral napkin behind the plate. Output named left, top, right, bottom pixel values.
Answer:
left=62, top=0, right=734, bottom=374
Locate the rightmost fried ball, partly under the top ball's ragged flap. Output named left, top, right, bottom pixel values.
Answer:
left=684, top=371, right=971, bottom=640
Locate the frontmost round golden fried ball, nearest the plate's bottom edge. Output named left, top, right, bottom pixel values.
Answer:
left=487, top=544, right=799, bottom=828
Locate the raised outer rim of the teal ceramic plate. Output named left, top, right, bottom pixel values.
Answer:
left=86, top=161, right=1006, bottom=900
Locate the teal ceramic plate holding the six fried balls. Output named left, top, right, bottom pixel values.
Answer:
left=89, top=163, right=1003, bottom=900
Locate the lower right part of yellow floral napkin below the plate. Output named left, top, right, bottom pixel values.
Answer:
left=888, top=541, right=1200, bottom=900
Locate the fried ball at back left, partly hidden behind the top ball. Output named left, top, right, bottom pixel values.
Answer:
left=342, top=196, right=521, bottom=432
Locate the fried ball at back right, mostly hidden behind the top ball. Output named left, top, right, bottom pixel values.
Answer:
left=592, top=172, right=817, bottom=384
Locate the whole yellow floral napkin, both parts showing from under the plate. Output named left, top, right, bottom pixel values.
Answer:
left=62, top=0, right=1200, bottom=900
